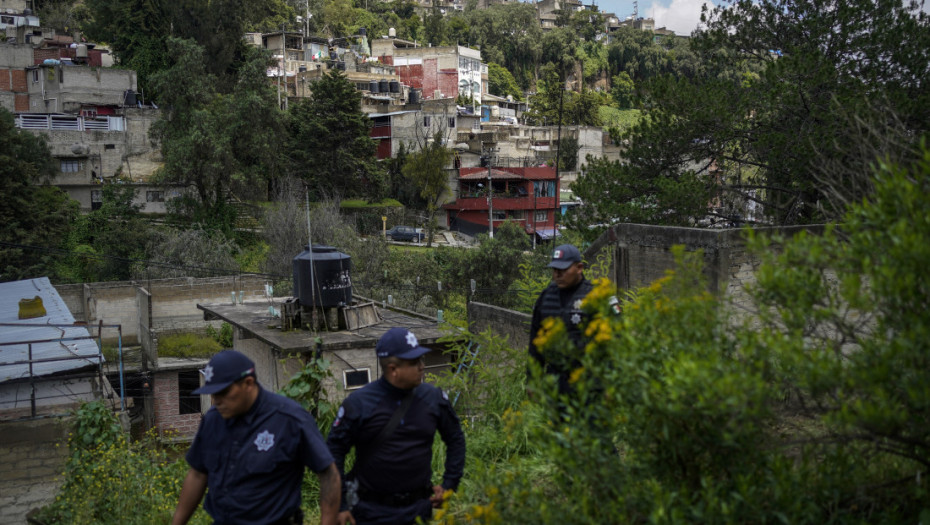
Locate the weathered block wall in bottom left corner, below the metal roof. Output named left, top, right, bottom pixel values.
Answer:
left=0, top=418, right=70, bottom=525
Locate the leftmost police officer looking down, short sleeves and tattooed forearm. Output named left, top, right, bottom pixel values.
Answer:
left=171, top=350, right=340, bottom=525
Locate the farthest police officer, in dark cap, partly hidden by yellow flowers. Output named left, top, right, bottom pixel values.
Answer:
left=529, top=244, right=593, bottom=394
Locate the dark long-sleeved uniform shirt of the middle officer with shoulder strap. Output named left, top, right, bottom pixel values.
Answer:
left=326, top=377, right=465, bottom=508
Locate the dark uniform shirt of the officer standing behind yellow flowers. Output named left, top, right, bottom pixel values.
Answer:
left=529, top=276, right=594, bottom=394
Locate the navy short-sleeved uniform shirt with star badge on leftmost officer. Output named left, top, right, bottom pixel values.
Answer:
left=187, top=387, right=333, bottom=525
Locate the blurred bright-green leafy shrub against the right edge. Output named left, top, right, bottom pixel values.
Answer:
left=753, top=147, right=930, bottom=470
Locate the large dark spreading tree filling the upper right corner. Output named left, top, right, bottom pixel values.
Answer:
left=579, top=0, right=930, bottom=225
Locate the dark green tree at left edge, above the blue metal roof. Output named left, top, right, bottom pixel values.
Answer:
left=0, top=108, right=78, bottom=281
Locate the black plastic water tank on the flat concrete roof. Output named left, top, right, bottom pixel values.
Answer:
left=292, top=244, right=352, bottom=308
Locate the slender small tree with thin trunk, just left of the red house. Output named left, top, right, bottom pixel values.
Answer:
left=403, top=130, right=452, bottom=247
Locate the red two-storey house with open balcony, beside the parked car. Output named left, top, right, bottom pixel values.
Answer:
left=443, top=167, right=559, bottom=239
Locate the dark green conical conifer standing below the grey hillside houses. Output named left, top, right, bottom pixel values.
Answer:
left=285, top=70, right=386, bottom=199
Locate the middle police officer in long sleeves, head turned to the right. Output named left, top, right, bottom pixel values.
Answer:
left=327, top=328, right=465, bottom=525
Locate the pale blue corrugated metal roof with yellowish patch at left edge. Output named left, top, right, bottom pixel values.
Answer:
left=0, top=277, right=102, bottom=382
